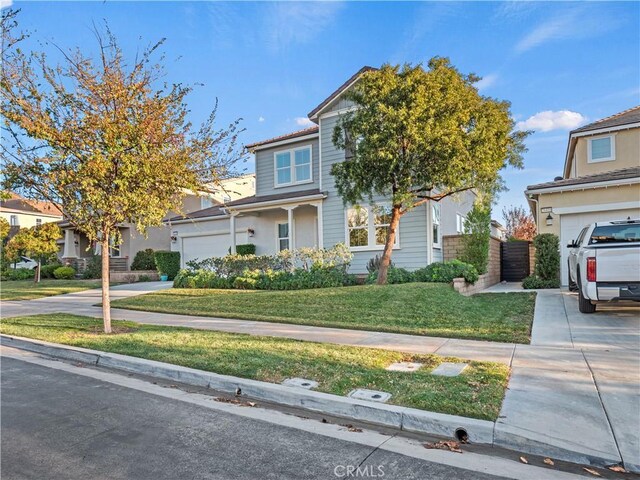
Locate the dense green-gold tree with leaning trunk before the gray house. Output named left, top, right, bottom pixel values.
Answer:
left=331, top=58, right=528, bottom=284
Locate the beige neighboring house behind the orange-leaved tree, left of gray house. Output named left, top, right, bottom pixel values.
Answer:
left=58, top=174, right=255, bottom=271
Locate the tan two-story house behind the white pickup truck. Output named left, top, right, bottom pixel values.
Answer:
left=525, top=106, right=640, bottom=285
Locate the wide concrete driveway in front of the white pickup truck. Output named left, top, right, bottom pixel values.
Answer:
left=496, top=291, right=640, bottom=472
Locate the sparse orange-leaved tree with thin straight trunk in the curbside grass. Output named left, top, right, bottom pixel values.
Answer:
left=0, top=10, right=240, bottom=333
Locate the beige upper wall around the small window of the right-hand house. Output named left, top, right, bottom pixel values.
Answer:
left=570, top=128, right=640, bottom=178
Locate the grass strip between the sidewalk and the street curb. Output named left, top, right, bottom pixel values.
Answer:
left=0, top=314, right=509, bottom=420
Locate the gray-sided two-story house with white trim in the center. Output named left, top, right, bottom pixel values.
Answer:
left=170, top=67, right=475, bottom=273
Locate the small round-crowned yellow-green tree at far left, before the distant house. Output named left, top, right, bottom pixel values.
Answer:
left=5, top=223, right=62, bottom=283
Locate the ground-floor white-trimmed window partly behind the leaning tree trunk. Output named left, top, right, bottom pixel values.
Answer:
left=347, top=203, right=398, bottom=249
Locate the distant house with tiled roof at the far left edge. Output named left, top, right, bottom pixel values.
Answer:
left=0, top=193, right=62, bottom=236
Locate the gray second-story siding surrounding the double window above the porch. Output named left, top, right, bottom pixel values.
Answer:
left=255, top=137, right=320, bottom=196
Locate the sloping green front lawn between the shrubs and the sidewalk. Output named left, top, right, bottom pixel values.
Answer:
left=112, top=283, right=535, bottom=343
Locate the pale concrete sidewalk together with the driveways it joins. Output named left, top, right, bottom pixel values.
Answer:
left=2, top=282, right=640, bottom=471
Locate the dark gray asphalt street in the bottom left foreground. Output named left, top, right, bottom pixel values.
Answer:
left=1, top=357, right=510, bottom=480
